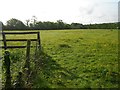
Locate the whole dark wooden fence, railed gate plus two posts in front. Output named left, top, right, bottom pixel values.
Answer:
left=0, top=32, right=41, bottom=88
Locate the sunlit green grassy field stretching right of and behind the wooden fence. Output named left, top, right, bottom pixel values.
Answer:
left=0, top=30, right=120, bottom=88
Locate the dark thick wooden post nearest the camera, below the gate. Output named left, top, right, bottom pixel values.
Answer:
left=4, top=51, right=11, bottom=88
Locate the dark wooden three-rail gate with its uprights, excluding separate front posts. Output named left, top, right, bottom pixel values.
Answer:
left=0, top=32, right=41, bottom=50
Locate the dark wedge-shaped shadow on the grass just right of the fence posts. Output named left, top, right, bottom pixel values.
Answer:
left=33, top=52, right=78, bottom=88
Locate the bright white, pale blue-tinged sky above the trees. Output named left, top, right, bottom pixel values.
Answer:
left=0, top=0, right=120, bottom=24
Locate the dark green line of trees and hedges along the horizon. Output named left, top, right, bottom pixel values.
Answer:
left=3, top=17, right=120, bottom=30
